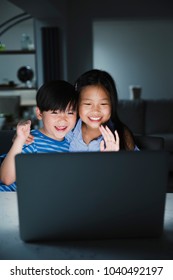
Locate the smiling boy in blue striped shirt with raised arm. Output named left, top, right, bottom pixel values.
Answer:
left=0, top=80, right=77, bottom=191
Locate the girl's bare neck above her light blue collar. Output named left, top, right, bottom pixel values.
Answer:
left=82, top=123, right=101, bottom=145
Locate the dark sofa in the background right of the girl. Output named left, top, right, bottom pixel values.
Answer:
left=117, top=99, right=173, bottom=190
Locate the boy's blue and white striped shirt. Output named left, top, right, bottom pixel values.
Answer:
left=0, top=129, right=69, bottom=192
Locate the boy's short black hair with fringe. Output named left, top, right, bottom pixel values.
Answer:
left=36, top=80, right=77, bottom=112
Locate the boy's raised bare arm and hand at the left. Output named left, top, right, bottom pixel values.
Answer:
left=0, top=121, right=31, bottom=185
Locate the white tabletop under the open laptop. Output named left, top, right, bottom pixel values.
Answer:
left=0, top=192, right=173, bottom=260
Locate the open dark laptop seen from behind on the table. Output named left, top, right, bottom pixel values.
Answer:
left=16, top=151, right=168, bottom=242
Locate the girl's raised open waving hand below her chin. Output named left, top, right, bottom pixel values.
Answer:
left=100, top=125, right=120, bottom=152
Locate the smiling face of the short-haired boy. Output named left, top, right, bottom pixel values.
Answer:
left=36, top=106, right=77, bottom=141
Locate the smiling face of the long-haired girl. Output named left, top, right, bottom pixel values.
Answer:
left=79, top=86, right=111, bottom=129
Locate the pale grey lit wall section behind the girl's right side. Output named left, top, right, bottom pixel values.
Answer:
left=93, top=20, right=173, bottom=99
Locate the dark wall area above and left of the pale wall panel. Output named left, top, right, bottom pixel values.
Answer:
left=68, top=0, right=173, bottom=86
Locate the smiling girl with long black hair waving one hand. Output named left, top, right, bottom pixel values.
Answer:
left=68, top=69, right=138, bottom=152
